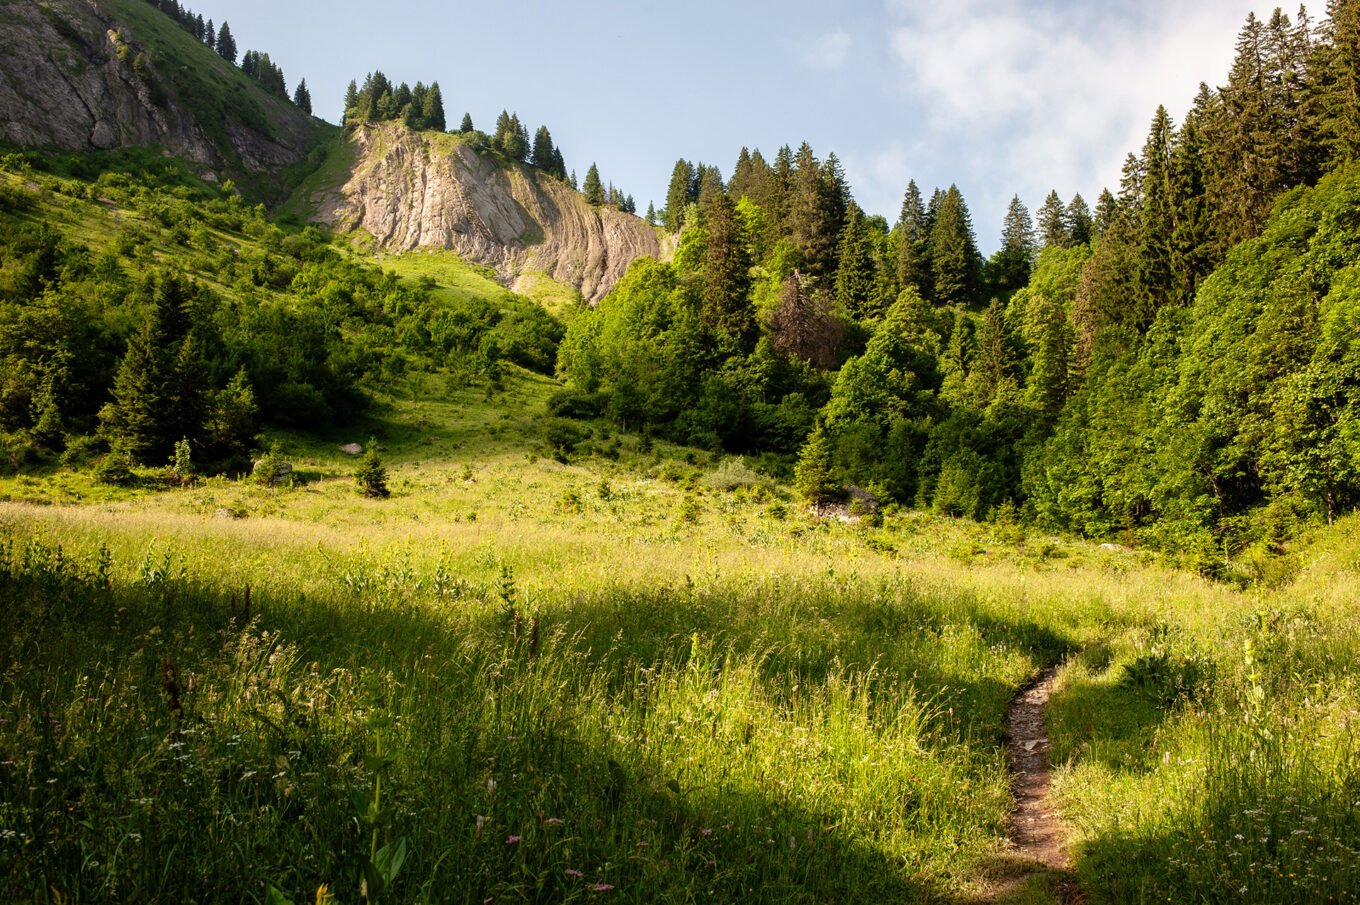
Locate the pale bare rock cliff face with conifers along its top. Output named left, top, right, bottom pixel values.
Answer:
left=310, top=124, right=662, bottom=302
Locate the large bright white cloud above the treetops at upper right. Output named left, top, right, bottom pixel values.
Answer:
left=887, top=0, right=1267, bottom=246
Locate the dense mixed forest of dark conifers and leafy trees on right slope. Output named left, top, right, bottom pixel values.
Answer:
left=558, top=0, right=1360, bottom=562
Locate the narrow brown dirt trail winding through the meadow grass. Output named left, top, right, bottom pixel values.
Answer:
left=978, top=667, right=1085, bottom=905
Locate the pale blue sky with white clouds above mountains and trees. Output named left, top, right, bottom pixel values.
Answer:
left=198, top=0, right=1272, bottom=253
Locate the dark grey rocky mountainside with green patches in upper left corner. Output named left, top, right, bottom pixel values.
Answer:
left=0, top=0, right=325, bottom=182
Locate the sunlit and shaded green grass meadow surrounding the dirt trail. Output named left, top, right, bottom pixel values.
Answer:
left=0, top=364, right=1360, bottom=902
